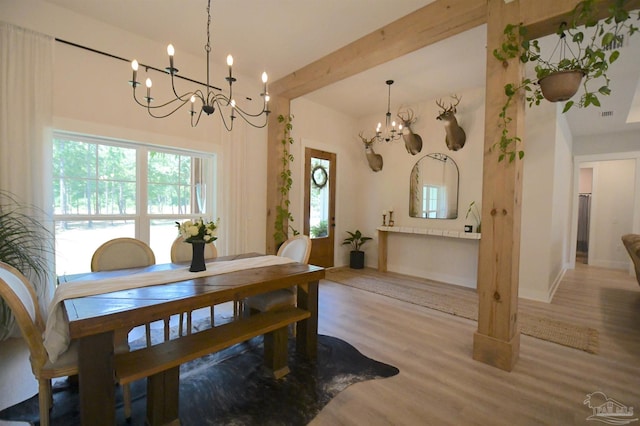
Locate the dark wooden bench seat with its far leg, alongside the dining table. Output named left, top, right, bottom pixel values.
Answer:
left=114, top=307, right=311, bottom=384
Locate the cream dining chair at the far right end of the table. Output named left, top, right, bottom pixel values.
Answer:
left=243, top=234, right=311, bottom=314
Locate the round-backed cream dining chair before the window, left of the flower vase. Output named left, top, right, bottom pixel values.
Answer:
left=91, top=237, right=157, bottom=419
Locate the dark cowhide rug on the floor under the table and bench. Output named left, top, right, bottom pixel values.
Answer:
left=0, top=335, right=399, bottom=426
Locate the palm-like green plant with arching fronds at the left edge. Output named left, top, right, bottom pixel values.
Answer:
left=0, top=190, right=53, bottom=341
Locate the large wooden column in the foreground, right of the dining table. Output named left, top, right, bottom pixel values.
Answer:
left=473, top=0, right=524, bottom=371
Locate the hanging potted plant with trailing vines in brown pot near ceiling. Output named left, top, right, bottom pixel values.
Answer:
left=493, top=0, right=640, bottom=162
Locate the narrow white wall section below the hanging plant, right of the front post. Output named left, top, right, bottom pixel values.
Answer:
left=519, top=102, right=573, bottom=302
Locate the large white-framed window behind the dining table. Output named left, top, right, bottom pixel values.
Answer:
left=53, top=132, right=215, bottom=275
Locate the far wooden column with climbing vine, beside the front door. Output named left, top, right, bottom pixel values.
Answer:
left=265, top=95, right=295, bottom=254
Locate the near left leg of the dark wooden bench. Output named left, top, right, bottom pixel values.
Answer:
left=146, top=366, right=180, bottom=426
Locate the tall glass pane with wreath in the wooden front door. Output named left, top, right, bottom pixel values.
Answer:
left=309, top=157, right=331, bottom=238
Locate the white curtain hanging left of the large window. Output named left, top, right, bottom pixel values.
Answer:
left=0, top=22, right=54, bottom=336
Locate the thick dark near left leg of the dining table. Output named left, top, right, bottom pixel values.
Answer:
left=78, top=331, right=116, bottom=426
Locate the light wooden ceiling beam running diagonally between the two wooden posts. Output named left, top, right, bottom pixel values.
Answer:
left=269, top=0, right=486, bottom=99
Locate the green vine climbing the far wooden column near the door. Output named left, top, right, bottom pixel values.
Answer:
left=273, top=114, right=299, bottom=246
